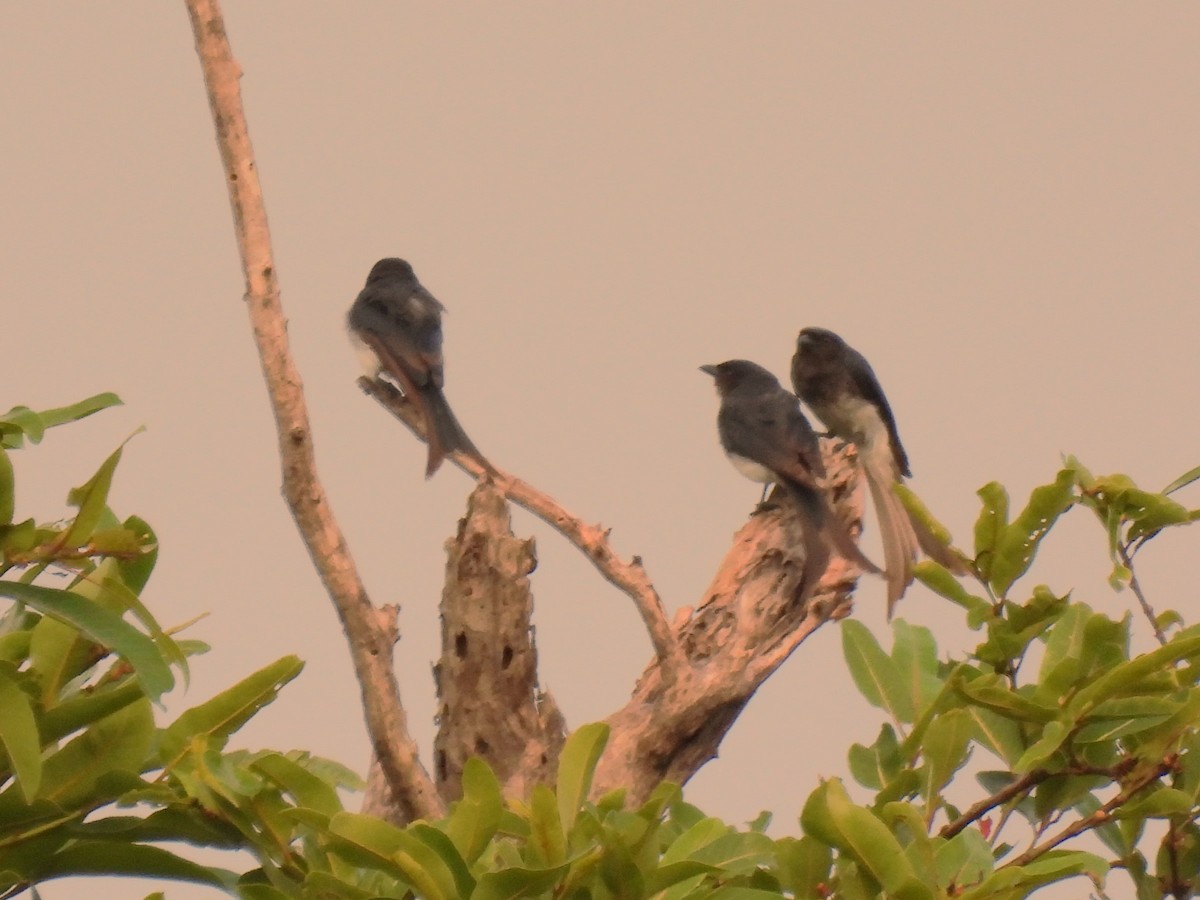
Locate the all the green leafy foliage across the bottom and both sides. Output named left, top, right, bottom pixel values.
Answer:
left=0, top=395, right=1200, bottom=900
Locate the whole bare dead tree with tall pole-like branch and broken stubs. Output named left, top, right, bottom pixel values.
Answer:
left=187, top=0, right=862, bottom=821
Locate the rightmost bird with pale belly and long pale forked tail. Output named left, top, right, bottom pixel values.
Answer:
left=792, top=328, right=966, bottom=619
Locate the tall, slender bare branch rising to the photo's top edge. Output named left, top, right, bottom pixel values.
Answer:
left=186, top=0, right=444, bottom=820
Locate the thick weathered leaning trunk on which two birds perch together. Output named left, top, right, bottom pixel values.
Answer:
left=592, top=442, right=863, bottom=804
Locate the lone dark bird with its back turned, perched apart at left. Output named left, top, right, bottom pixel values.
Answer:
left=347, top=258, right=496, bottom=478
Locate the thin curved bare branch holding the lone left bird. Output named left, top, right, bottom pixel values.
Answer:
left=359, top=377, right=688, bottom=682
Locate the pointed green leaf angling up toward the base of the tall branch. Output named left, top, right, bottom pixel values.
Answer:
left=158, top=656, right=304, bottom=768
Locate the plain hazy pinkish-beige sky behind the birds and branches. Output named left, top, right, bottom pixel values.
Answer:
left=0, top=0, right=1200, bottom=900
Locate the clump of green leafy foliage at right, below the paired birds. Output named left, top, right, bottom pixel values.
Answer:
left=825, top=460, right=1200, bottom=899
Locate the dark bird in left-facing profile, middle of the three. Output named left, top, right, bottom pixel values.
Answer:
left=700, top=359, right=880, bottom=600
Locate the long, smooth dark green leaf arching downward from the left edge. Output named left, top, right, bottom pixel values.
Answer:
left=0, top=581, right=175, bottom=702
